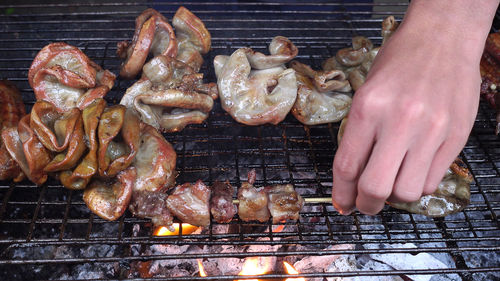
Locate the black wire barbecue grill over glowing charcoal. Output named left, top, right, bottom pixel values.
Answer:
left=0, top=0, right=500, bottom=280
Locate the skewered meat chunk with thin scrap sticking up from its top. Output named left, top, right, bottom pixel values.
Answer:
left=238, top=170, right=271, bottom=222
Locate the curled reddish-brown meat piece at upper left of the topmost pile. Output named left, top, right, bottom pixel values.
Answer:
left=117, top=9, right=177, bottom=79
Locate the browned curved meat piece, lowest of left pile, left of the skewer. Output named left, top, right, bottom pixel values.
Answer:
left=83, top=167, right=136, bottom=221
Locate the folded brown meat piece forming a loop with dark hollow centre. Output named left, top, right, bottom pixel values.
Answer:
left=97, top=105, right=140, bottom=177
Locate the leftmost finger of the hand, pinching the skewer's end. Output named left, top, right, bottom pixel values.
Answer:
left=332, top=109, right=375, bottom=215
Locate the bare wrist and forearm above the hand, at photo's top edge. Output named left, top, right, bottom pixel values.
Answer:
left=400, top=0, right=500, bottom=61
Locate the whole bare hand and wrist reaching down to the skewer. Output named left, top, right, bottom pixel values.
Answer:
left=332, top=0, right=500, bottom=215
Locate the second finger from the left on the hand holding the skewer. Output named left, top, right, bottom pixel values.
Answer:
left=356, top=134, right=407, bottom=215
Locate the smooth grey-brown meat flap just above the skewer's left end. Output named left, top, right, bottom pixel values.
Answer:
left=132, top=124, right=177, bottom=192
